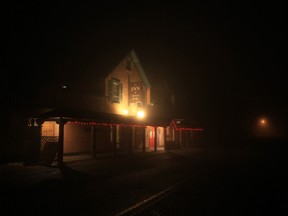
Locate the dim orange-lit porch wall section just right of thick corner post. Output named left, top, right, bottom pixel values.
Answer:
left=64, top=123, right=92, bottom=155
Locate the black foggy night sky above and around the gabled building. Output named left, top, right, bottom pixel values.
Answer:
left=2, top=1, right=288, bottom=142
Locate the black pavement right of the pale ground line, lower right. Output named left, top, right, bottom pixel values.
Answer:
left=135, top=147, right=288, bottom=216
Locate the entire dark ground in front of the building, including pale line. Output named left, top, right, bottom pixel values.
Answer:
left=0, top=139, right=288, bottom=216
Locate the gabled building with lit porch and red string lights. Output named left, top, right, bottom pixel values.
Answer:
left=25, top=50, right=202, bottom=164
